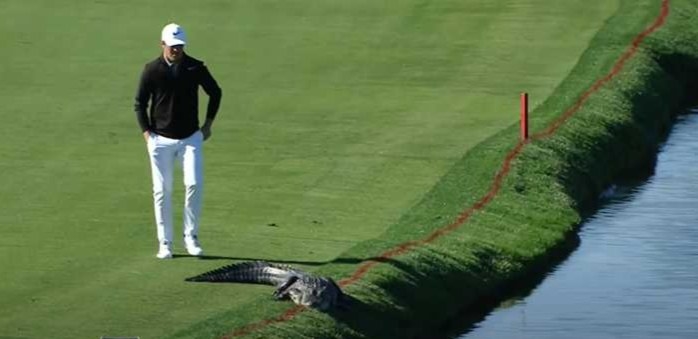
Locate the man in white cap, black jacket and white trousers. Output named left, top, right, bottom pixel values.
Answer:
left=135, top=23, right=221, bottom=259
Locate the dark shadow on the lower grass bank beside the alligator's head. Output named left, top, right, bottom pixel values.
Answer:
left=329, top=232, right=580, bottom=339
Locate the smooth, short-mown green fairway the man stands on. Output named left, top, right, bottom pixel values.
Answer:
left=0, top=0, right=617, bottom=339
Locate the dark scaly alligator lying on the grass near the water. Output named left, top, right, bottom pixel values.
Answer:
left=185, top=261, right=346, bottom=312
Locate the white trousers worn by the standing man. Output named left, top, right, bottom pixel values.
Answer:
left=148, top=131, right=204, bottom=244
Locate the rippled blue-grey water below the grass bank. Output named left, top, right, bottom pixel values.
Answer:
left=459, top=112, right=698, bottom=339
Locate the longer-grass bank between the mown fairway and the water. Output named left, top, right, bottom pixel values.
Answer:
left=170, top=0, right=698, bottom=338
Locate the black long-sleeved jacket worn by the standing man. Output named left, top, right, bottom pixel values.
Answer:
left=135, top=54, right=222, bottom=139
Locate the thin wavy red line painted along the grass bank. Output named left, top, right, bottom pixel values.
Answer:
left=220, top=0, right=670, bottom=339
